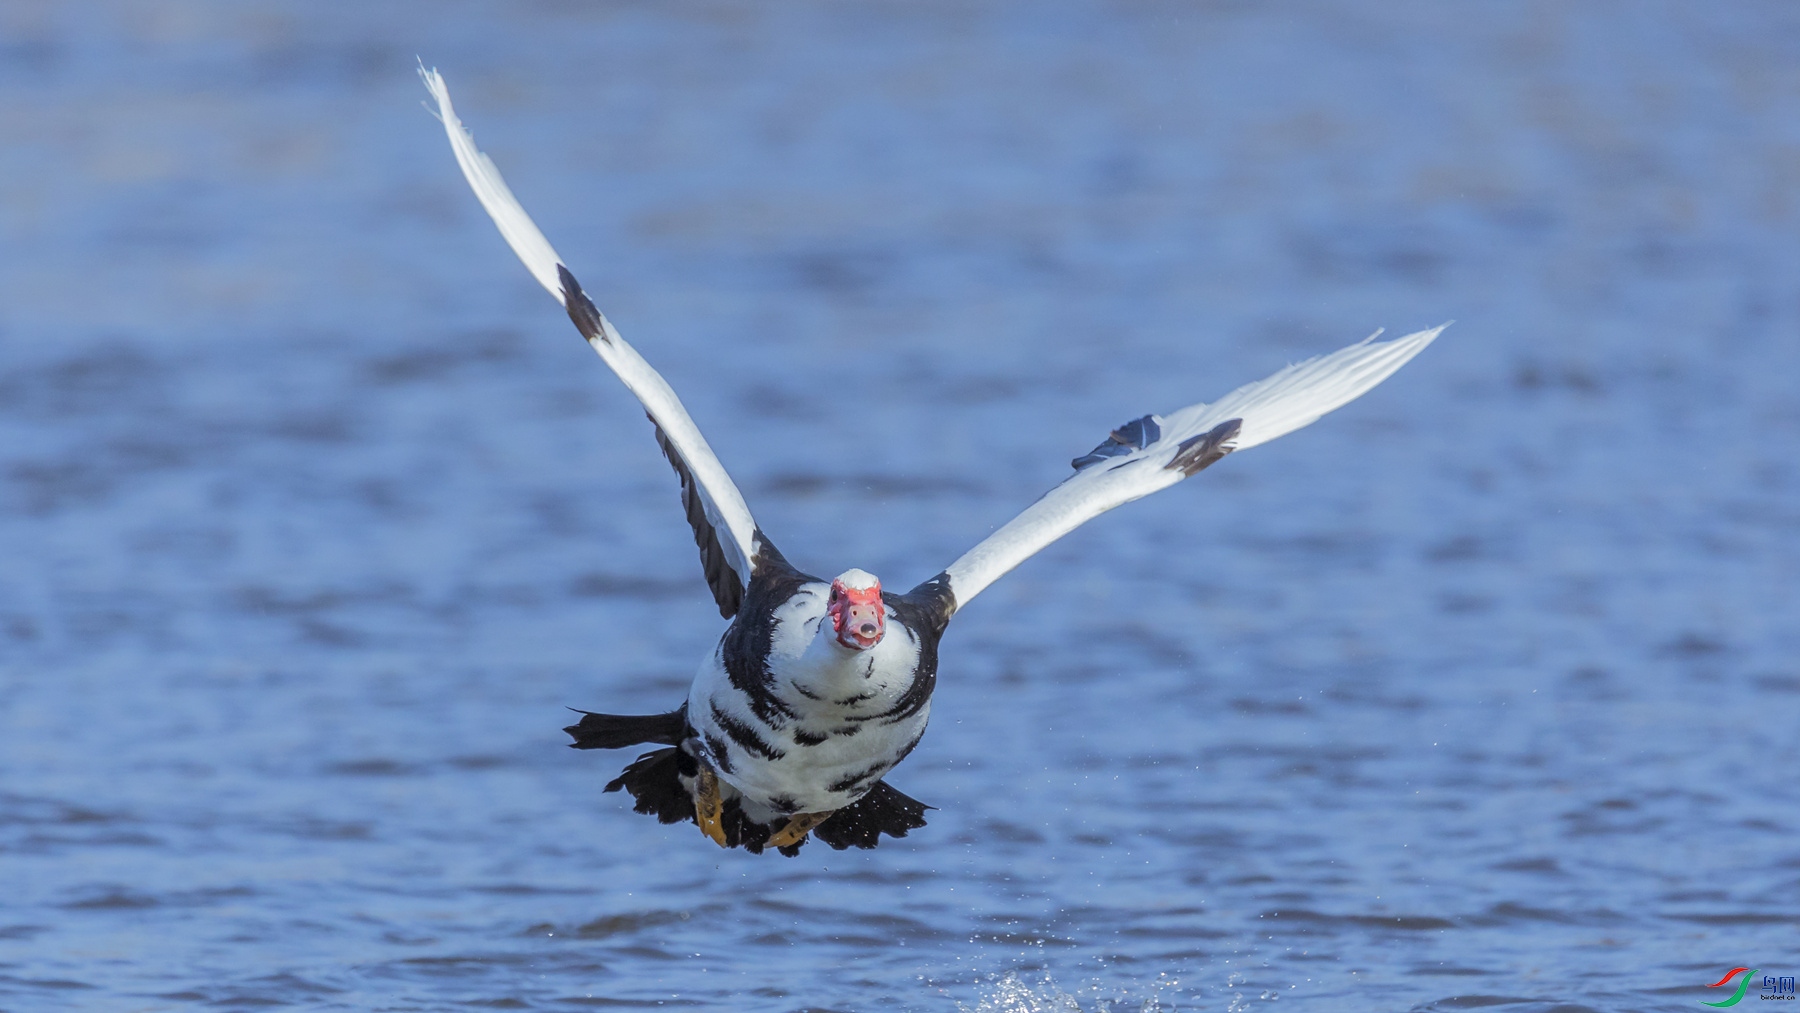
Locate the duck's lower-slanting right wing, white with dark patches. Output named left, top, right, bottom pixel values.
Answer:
left=922, top=324, right=1447, bottom=608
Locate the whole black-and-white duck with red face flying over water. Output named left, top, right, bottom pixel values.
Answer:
left=419, top=67, right=1444, bottom=855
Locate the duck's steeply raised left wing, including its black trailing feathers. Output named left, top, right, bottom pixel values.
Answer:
left=419, top=67, right=779, bottom=619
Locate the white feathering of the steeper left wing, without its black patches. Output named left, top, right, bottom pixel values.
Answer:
left=419, top=67, right=756, bottom=597
